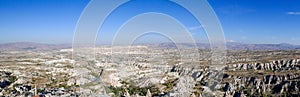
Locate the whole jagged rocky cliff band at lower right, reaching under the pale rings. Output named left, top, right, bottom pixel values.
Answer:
left=171, top=59, right=300, bottom=97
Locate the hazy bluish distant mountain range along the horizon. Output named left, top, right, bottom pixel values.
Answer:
left=0, top=42, right=300, bottom=50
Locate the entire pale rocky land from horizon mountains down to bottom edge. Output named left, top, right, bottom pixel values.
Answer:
left=0, top=42, right=300, bottom=97
